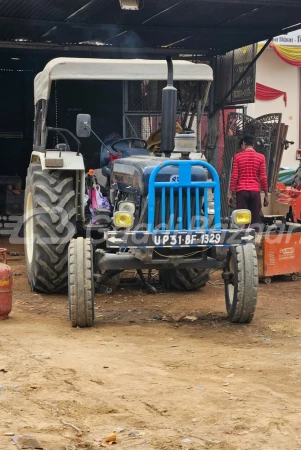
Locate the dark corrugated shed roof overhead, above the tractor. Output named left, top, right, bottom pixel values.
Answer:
left=0, top=0, right=301, bottom=54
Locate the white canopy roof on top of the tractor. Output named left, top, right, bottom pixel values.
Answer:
left=34, top=58, right=213, bottom=104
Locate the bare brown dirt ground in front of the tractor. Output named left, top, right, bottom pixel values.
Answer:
left=0, top=242, right=301, bottom=450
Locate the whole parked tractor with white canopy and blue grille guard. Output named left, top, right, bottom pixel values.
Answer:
left=24, top=56, right=258, bottom=327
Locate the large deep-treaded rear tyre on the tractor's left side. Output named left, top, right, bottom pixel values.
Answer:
left=24, top=163, right=76, bottom=293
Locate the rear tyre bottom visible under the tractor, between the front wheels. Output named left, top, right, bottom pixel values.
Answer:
left=159, top=269, right=210, bottom=291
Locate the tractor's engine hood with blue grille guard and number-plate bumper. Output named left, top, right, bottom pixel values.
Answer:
left=106, top=157, right=255, bottom=250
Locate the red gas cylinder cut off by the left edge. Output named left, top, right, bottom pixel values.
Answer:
left=0, top=248, right=13, bottom=320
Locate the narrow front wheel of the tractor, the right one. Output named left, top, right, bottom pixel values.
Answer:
left=223, top=244, right=258, bottom=323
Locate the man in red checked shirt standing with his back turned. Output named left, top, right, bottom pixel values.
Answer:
left=228, top=136, right=269, bottom=231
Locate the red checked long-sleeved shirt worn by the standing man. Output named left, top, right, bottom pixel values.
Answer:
left=230, top=147, right=268, bottom=192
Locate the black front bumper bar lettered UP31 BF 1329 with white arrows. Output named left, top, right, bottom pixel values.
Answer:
left=105, top=230, right=254, bottom=248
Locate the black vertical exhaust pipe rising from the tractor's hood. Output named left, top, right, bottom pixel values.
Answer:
left=161, top=55, right=177, bottom=158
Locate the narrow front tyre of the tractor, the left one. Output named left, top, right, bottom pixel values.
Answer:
left=68, top=237, right=94, bottom=328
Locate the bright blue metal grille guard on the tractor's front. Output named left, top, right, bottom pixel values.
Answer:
left=147, top=160, right=221, bottom=231
